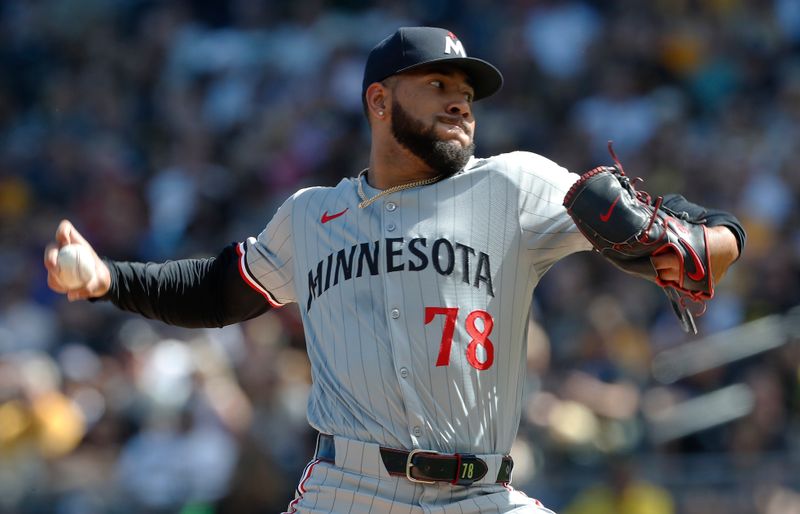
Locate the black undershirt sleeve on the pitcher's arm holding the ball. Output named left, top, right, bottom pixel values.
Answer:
left=99, top=244, right=270, bottom=328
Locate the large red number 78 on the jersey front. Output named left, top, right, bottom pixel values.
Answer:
left=425, top=307, right=494, bottom=370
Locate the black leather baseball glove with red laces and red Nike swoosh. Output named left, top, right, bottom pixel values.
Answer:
left=564, top=146, right=714, bottom=333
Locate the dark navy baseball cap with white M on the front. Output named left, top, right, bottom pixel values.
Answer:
left=361, top=27, right=503, bottom=100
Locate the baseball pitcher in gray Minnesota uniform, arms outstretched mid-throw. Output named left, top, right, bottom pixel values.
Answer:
left=45, top=27, right=745, bottom=514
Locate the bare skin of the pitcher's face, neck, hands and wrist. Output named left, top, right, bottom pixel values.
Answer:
left=44, top=64, right=739, bottom=301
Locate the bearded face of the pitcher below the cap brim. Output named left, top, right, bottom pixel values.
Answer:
left=391, top=68, right=475, bottom=175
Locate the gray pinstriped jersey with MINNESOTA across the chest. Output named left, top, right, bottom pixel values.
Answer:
left=242, top=152, right=591, bottom=454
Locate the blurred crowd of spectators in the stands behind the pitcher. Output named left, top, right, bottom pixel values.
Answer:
left=0, top=0, right=800, bottom=514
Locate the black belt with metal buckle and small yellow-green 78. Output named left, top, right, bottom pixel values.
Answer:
left=316, top=434, right=514, bottom=486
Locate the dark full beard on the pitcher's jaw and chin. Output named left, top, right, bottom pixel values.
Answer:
left=391, top=102, right=475, bottom=177
